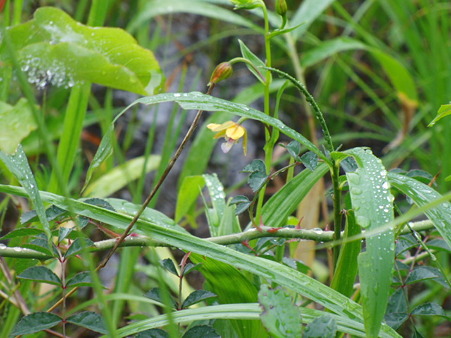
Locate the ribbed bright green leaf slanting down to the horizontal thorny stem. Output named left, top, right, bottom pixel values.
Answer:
left=262, top=163, right=328, bottom=228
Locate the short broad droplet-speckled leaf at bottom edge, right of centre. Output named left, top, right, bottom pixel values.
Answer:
left=258, top=284, right=302, bottom=338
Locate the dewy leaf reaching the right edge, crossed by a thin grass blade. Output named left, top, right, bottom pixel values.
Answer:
left=388, top=172, right=451, bottom=246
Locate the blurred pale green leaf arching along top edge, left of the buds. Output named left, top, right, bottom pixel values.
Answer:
left=127, top=0, right=261, bottom=33
